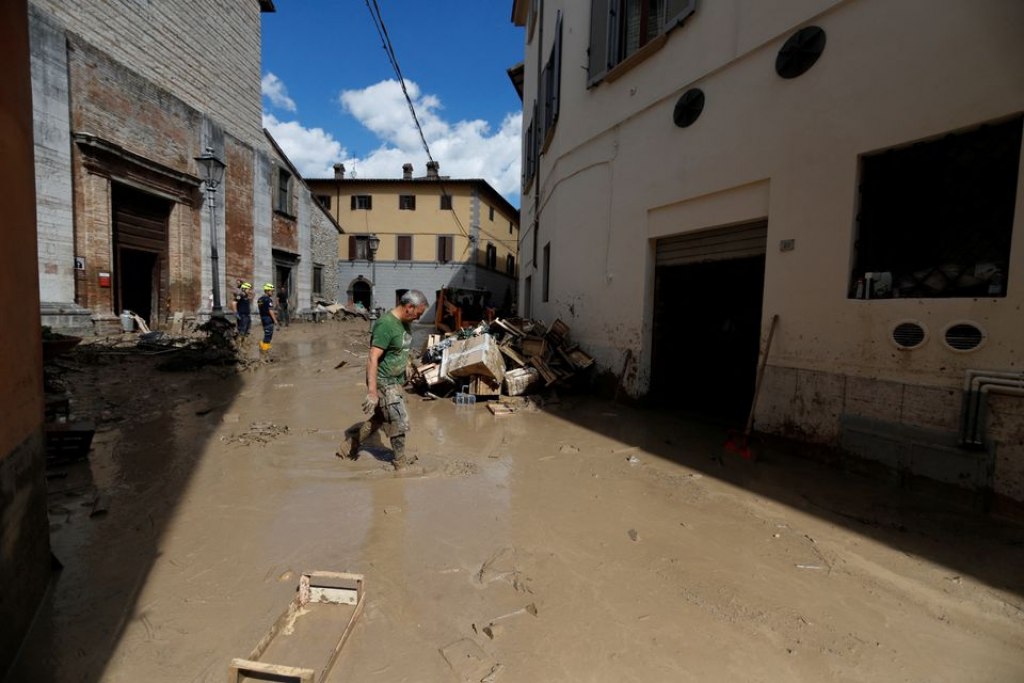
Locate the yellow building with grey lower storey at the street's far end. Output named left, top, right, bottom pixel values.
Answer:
left=306, top=162, right=519, bottom=319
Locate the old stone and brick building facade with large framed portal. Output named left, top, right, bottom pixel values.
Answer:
left=30, top=0, right=331, bottom=333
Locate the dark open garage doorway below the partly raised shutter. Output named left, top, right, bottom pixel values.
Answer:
left=650, top=255, right=765, bottom=421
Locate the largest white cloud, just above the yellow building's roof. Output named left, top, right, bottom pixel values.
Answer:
left=338, top=80, right=522, bottom=198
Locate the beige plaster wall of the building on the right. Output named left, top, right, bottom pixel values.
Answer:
left=521, top=0, right=1024, bottom=394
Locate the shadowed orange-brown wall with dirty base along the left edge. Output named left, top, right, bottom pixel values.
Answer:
left=0, top=0, right=50, bottom=677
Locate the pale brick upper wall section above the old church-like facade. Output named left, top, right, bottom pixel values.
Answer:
left=33, top=0, right=263, bottom=146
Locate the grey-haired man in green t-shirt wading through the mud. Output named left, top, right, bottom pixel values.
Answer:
left=338, top=290, right=427, bottom=470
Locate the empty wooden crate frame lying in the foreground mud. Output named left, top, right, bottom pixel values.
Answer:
left=227, top=571, right=366, bottom=683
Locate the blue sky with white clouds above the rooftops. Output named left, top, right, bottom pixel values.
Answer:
left=262, top=0, right=523, bottom=206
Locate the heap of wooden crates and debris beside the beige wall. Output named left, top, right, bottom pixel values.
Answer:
left=413, top=318, right=594, bottom=414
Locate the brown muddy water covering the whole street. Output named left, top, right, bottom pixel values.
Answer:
left=9, top=323, right=1024, bottom=682
